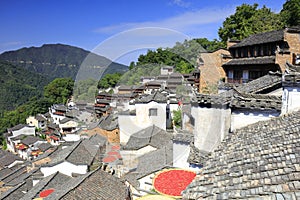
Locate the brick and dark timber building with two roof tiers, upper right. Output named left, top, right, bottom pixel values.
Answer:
left=222, top=27, right=300, bottom=83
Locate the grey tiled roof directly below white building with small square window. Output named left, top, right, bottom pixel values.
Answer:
left=123, top=125, right=172, bottom=150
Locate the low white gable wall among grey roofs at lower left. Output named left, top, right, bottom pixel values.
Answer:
left=41, top=161, right=88, bottom=177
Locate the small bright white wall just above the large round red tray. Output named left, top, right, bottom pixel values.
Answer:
left=173, top=142, right=190, bottom=169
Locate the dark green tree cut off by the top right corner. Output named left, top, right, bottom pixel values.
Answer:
left=280, top=0, right=300, bottom=27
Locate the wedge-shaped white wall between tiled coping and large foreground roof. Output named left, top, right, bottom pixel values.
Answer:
left=230, top=111, right=279, bottom=131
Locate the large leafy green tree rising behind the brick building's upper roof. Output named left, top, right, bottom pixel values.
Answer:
left=218, top=4, right=283, bottom=43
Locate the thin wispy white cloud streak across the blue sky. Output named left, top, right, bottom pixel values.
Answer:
left=96, top=7, right=235, bottom=34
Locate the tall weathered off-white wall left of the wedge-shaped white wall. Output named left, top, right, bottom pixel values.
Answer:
left=191, top=106, right=230, bottom=152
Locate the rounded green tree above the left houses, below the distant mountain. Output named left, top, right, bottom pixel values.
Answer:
left=44, top=78, right=74, bottom=104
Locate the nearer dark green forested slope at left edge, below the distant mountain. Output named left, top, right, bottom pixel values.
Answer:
left=0, top=61, right=50, bottom=113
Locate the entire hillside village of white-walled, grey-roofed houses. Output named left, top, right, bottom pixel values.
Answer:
left=0, top=27, right=300, bottom=200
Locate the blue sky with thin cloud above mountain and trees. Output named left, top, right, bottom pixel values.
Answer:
left=0, top=0, right=285, bottom=63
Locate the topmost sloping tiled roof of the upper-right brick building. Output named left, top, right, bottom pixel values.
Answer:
left=229, top=30, right=284, bottom=49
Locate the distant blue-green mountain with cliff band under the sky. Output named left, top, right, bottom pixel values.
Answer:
left=0, top=44, right=128, bottom=80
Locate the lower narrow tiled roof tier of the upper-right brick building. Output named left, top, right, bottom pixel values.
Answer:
left=223, top=56, right=275, bottom=67
